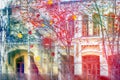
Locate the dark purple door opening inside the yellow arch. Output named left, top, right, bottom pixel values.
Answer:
left=16, top=56, right=24, bottom=73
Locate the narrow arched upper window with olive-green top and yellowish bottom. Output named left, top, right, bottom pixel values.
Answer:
left=92, top=13, right=100, bottom=36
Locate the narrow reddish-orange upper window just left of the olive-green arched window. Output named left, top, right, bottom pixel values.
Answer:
left=82, top=15, right=88, bottom=36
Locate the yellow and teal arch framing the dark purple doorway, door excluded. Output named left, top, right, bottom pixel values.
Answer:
left=8, top=49, right=34, bottom=73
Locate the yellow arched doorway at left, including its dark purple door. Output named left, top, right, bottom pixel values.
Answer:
left=8, top=49, right=34, bottom=74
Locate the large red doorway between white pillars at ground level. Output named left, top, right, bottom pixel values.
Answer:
left=82, top=55, right=100, bottom=80
